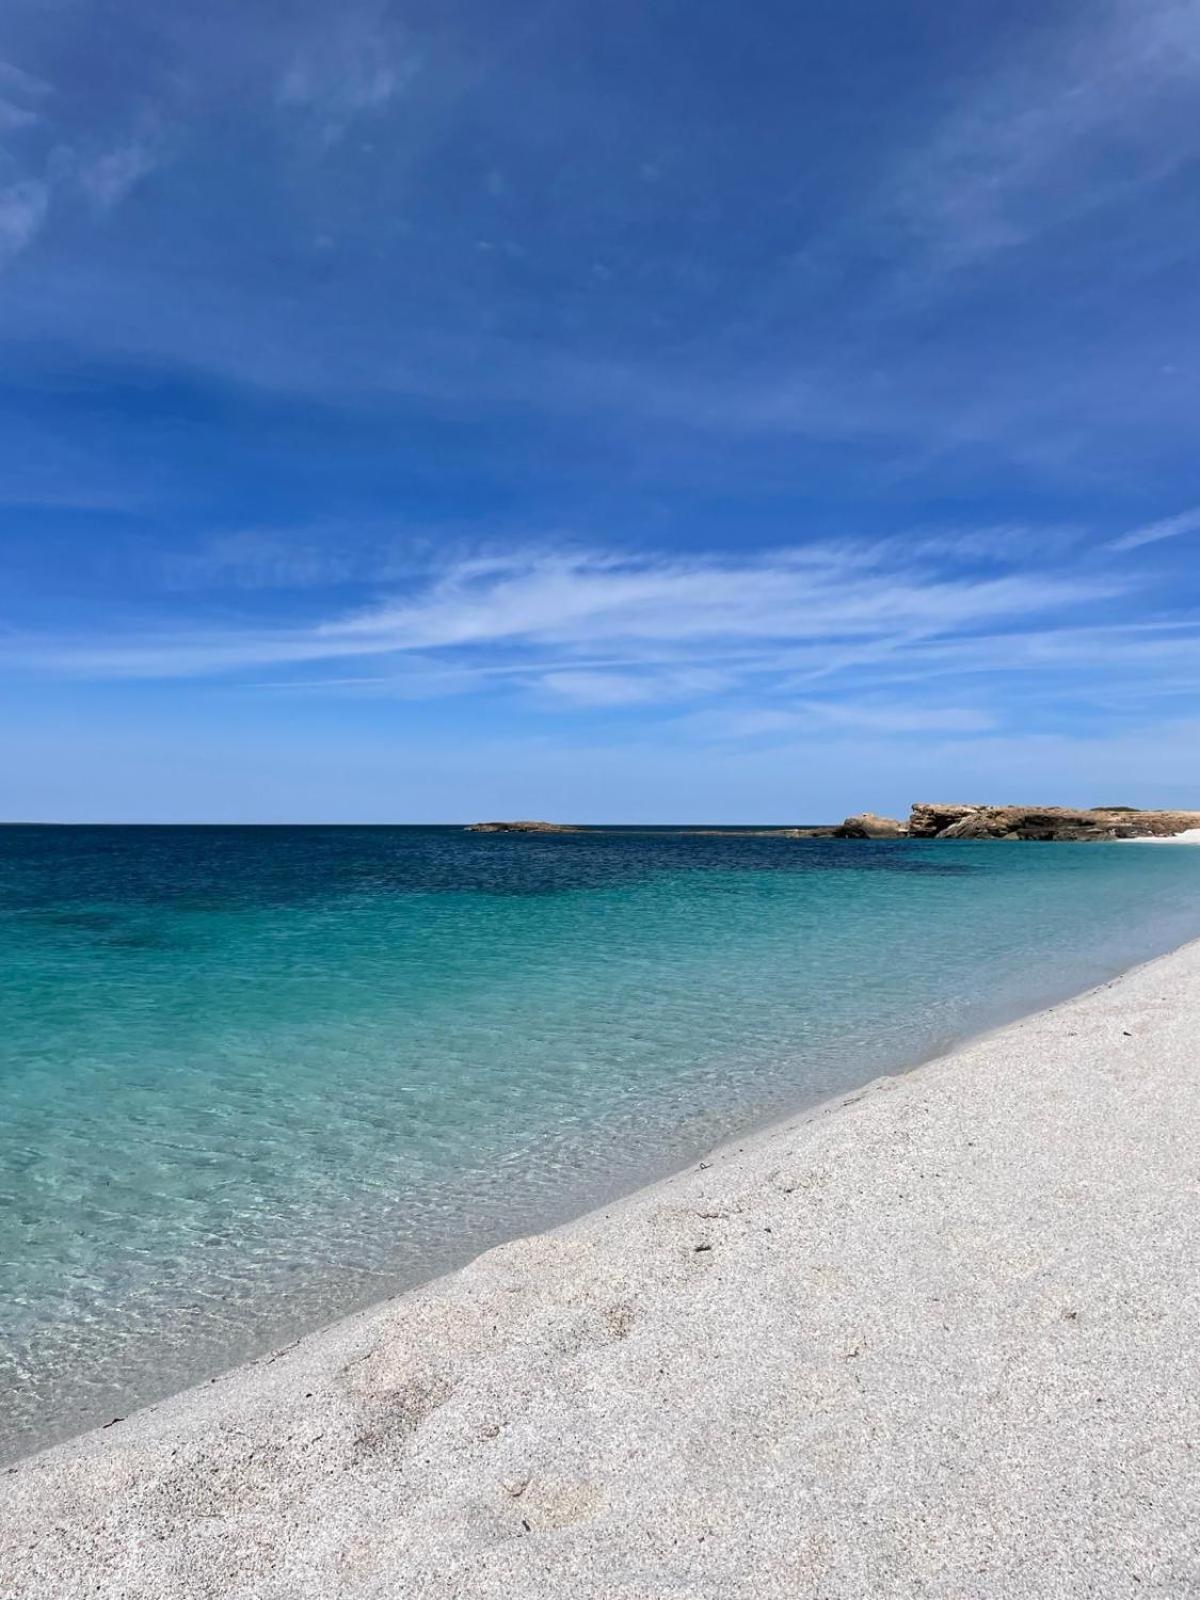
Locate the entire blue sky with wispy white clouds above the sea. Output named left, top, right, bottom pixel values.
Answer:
left=0, top=0, right=1200, bottom=822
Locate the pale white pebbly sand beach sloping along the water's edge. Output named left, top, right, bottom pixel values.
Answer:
left=0, top=944, right=1200, bottom=1600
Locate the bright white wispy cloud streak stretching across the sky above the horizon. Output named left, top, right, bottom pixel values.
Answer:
left=0, top=541, right=1128, bottom=733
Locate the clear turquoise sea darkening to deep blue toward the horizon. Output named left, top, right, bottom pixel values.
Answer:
left=0, top=827, right=1200, bottom=1456
